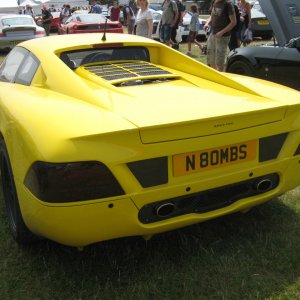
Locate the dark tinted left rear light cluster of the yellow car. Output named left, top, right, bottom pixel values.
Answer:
left=24, top=161, right=124, bottom=203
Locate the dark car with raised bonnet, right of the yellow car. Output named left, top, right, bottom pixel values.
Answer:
left=226, top=0, right=300, bottom=90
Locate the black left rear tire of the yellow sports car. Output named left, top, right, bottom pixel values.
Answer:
left=0, top=139, right=37, bottom=244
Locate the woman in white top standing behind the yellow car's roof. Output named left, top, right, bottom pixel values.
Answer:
left=135, top=0, right=153, bottom=39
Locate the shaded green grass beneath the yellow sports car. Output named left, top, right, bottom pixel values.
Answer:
left=0, top=40, right=300, bottom=300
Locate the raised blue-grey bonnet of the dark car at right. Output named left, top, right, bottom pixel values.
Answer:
left=259, top=0, right=300, bottom=46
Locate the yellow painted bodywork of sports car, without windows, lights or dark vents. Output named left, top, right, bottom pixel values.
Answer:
left=0, top=34, right=300, bottom=246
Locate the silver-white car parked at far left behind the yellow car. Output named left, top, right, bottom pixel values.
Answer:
left=0, top=14, right=46, bottom=51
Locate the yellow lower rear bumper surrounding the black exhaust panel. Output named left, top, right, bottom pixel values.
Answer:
left=19, top=157, right=300, bottom=246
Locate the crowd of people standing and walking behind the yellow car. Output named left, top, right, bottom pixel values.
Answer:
left=22, top=0, right=251, bottom=71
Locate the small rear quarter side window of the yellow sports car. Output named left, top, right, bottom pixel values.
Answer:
left=15, top=53, right=39, bottom=85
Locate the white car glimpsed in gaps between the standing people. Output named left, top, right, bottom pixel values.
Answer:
left=152, top=10, right=206, bottom=41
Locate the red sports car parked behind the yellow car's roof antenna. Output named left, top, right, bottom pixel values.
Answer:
left=58, top=14, right=123, bottom=34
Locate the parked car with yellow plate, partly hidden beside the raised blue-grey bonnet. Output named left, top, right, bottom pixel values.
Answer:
left=251, top=1, right=273, bottom=40
